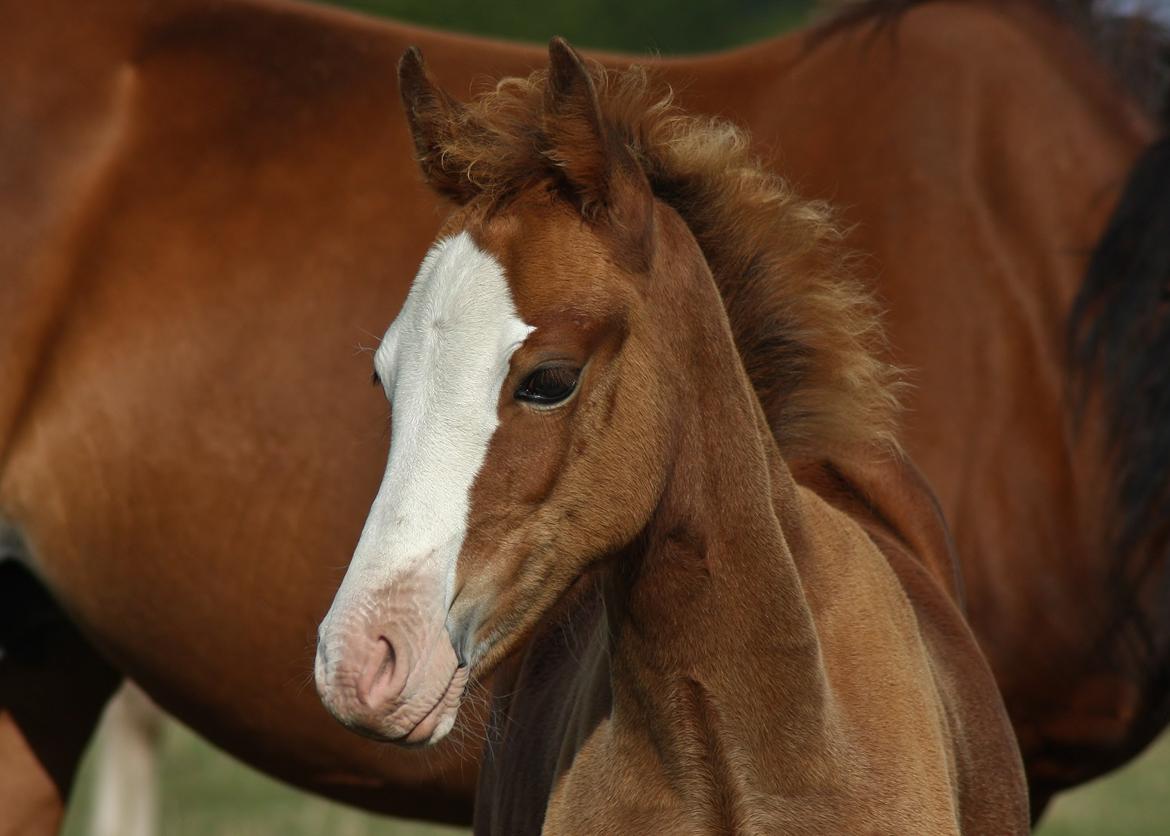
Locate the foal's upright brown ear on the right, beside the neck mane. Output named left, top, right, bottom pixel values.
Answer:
left=544, top=37, right=654, bottom=260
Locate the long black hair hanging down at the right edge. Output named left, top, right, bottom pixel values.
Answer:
left=1068, top=134, right=1170, bottom=739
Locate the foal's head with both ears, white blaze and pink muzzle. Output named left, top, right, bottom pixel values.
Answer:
left=316, top=41, right=893, bottom=744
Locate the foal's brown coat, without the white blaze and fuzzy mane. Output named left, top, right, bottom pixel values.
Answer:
left=388, top=42, right=1028, bottom=835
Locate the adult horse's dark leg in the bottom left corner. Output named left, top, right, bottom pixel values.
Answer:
left=0, top=559, right=121, bottom=836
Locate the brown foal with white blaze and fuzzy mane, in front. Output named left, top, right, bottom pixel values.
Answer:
left=316, top=41, right=1028, bottom=835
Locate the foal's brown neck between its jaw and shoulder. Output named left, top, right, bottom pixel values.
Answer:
left=604, top=258, right=833, bottom=801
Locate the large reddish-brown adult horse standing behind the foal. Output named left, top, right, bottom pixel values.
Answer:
left=0, top=0, right=1168, bottom=832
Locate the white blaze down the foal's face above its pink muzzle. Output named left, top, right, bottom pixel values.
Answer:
left=326, top=233, right=532, bottom=621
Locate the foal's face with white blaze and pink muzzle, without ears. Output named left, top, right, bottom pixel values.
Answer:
left=316, top=189, right=667, bottom=744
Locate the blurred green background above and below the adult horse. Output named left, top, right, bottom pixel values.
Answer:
left=66, top=0, right=1170, bottom=836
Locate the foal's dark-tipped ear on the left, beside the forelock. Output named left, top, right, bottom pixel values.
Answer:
left=398, top=47, right=475, bottom=205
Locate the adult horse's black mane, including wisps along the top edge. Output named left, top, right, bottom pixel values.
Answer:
left=837, top=0, right=1170, bottom=762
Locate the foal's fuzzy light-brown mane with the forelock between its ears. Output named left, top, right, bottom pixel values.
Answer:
left=420, top=62, right=897, bottom=456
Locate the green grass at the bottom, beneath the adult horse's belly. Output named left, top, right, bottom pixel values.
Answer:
left=64, top=710, right=1170, bottom=836
